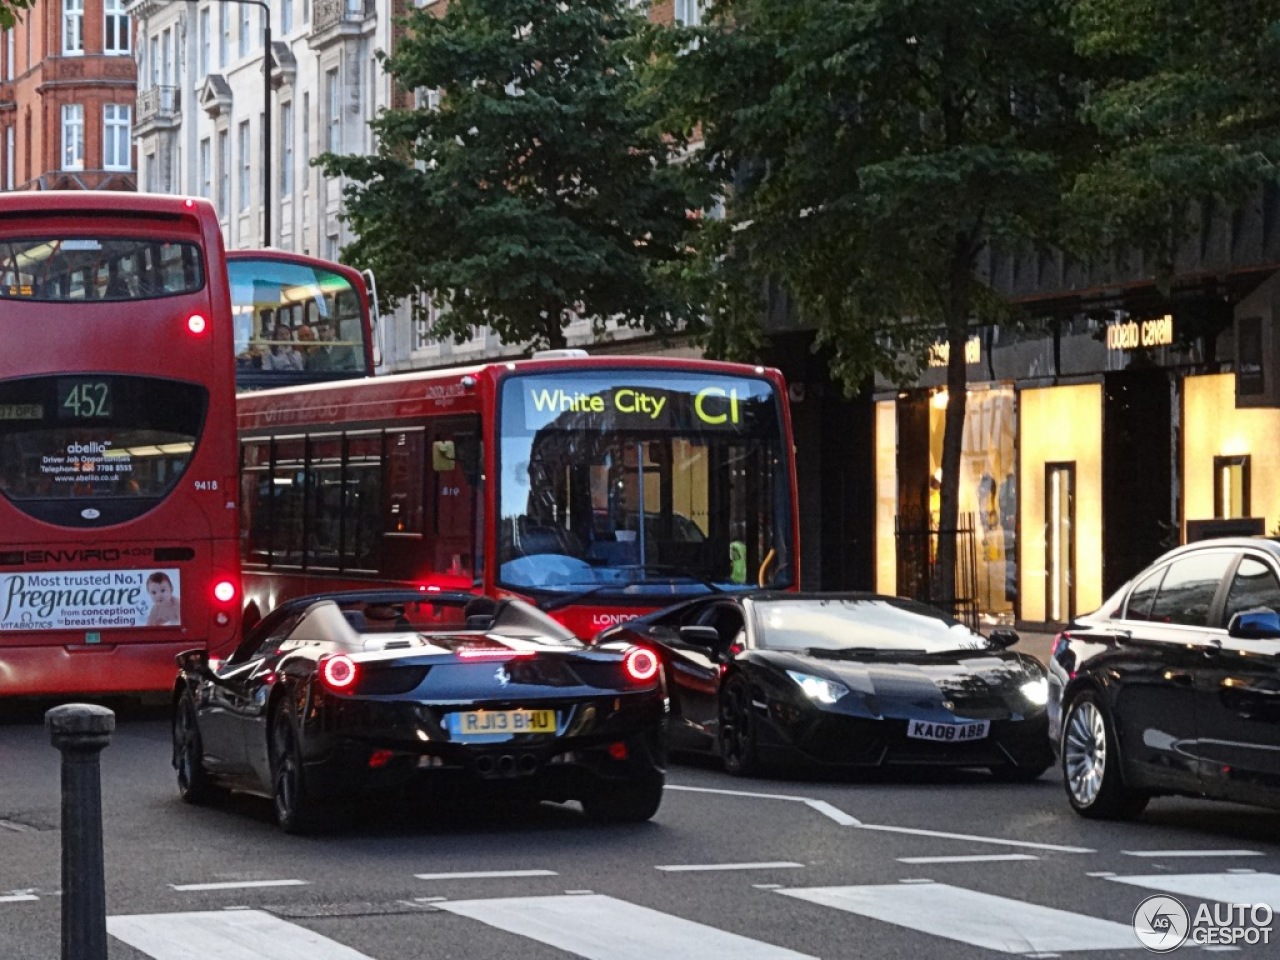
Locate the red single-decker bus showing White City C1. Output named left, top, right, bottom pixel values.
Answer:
left=238, top=351, right=799, bottom=637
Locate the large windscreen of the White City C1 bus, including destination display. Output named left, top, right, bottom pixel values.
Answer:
left=497, top=370, right=792, bottom=603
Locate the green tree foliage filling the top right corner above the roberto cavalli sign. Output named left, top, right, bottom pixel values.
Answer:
left=1073, top=0, right=1280, bottom=263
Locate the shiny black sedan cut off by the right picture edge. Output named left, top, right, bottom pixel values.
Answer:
left=1050, top=538, right=1280, bottom=819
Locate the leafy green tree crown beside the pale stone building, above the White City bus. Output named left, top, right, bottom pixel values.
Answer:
left=320, top=0, right=707, bottom=347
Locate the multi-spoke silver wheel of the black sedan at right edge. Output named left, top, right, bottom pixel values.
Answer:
left=1062, top=690, right=1149, bottom=819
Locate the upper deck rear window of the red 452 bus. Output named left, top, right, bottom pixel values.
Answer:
left=0, top=237, right=205, bottom=302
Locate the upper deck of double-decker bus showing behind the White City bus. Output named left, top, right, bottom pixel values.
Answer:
left=227, top=250, right=376, bottom=390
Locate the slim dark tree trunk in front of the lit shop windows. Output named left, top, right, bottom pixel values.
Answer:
left=932, top=248, right=973, bottom=616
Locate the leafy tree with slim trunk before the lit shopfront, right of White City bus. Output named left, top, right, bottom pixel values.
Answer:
left=669, top=0, right=1089, bottom=609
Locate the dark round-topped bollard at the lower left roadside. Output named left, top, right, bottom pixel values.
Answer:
left=45, top=703, right=115, bottom=960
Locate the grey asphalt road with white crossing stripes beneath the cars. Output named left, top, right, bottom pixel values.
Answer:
left=0, top=710, right=1280, bottom=960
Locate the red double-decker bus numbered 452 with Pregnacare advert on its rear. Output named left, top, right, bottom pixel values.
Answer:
left=0, top=192, right=241, bottom=696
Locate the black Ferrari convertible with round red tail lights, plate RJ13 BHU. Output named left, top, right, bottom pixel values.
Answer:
left=173, top=590, right=667, bottom=832
